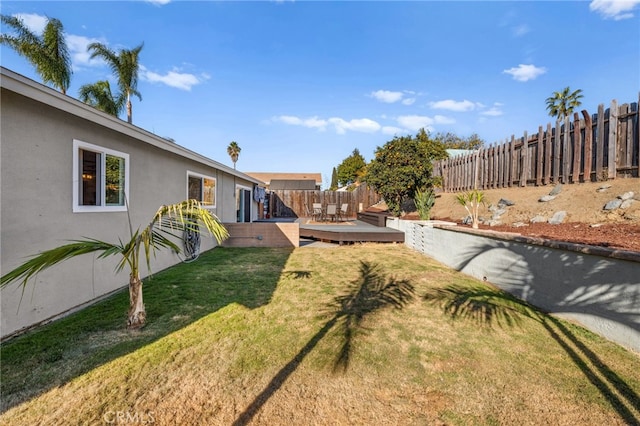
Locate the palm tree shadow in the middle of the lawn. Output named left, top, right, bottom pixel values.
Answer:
left=233, top=261, right=415, bottom=426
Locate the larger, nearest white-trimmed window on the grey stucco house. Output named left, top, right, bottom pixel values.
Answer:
left=73, top=140, right=129, bottom=212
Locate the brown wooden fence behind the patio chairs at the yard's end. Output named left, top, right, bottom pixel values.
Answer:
left=268, top=185, right=381, bottom=218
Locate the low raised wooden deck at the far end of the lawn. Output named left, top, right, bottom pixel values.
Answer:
left=297, top=218, right=404, bottom=244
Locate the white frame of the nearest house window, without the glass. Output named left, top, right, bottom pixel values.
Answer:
left=72, top=139, right=131, bottom=213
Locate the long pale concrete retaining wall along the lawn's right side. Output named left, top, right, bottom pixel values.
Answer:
left=387, top=218, right=640, bottom=352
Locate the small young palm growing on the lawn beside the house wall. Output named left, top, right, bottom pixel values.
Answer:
left=0, top=200, right=229, bottom=329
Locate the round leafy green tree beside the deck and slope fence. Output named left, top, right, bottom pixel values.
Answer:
left=366, top=129, right=447, bottom=216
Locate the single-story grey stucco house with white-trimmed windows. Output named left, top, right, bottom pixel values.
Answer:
left=0, top=67, right=262, bottom=339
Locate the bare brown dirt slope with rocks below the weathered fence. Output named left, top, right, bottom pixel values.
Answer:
left=422, top=178, right=640, bottom=252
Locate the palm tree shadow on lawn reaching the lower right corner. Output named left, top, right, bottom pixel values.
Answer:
left=422, top=285, right=640, bottom=425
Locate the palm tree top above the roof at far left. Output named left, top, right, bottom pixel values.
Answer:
left=0, top=15, right=72, bottom=94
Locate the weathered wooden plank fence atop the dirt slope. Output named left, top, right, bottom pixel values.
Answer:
left=434, top=95, right=640, bottom=192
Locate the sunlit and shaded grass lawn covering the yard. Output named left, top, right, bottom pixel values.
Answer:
left=0, top=244, right=640, bottom=425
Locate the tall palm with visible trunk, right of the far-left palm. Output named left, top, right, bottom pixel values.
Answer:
left=87, top=43, right=144, bottom=123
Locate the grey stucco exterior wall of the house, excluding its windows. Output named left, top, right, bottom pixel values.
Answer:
left=0, top=71, right=257, bottom=338
